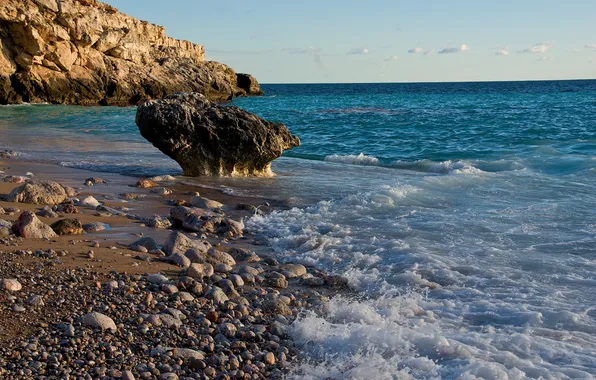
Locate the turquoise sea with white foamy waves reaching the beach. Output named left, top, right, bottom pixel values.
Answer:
left=0, top=80, right=596, bottom=380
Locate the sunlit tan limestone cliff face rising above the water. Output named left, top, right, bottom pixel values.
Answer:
left=0, top=0, right=261, bottom=105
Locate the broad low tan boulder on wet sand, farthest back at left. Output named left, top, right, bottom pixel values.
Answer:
left=6, top=181, right=75, bottom=205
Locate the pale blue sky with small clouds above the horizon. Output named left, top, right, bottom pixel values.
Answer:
left=105, top=0, right=596, bottom=83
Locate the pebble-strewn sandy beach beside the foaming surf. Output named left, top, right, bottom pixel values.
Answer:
left=0, top=158, right=346, bottom=378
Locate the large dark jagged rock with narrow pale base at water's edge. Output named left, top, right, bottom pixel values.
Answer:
left=136, top=93, right=300, bottom=177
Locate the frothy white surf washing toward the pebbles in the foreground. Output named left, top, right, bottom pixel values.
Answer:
left=247, top=177, right=596, bottom=380
